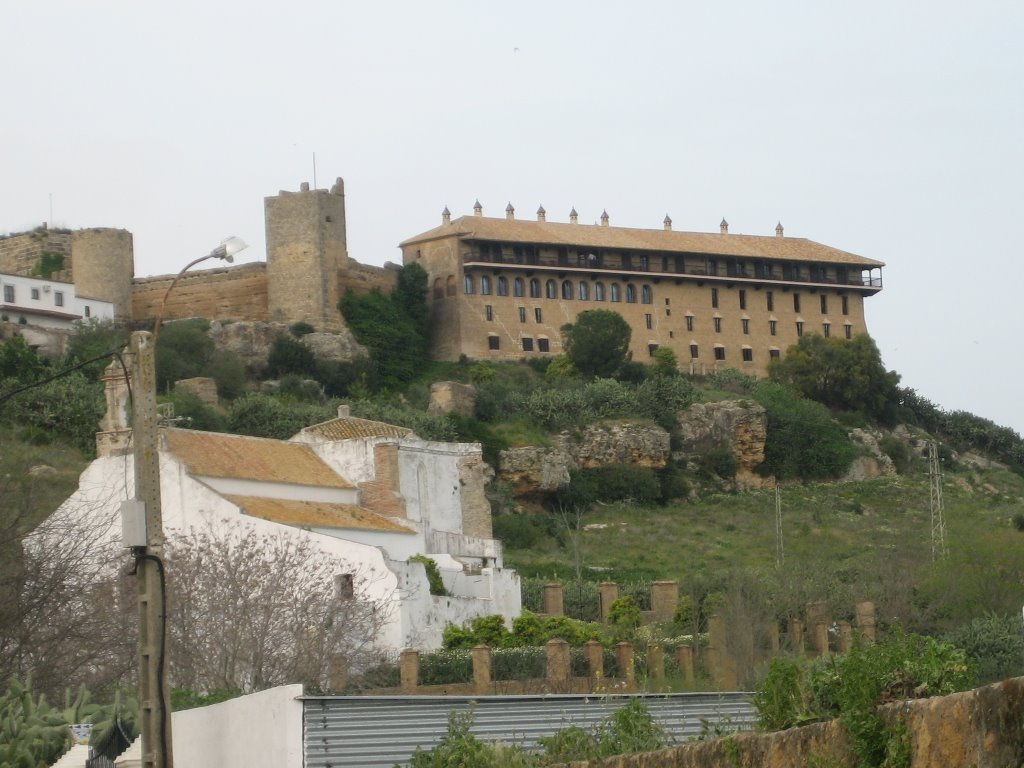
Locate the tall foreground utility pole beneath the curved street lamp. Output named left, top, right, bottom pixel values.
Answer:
left=131, top=331, right=174, bottom=768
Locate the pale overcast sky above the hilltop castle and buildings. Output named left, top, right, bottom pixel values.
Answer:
left=6, top=0, right=1024, bottom=431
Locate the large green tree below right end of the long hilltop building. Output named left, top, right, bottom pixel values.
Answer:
left=768, top=334, right=901, bottom=423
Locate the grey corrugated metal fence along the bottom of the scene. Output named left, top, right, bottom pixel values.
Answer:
left=303, top=693, right=754, bottom=768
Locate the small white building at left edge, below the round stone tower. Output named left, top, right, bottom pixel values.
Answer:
left=0, top=273, right=114, bottom=329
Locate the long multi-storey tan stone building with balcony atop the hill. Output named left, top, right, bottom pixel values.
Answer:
left=400, top=203, right=884, bottom=375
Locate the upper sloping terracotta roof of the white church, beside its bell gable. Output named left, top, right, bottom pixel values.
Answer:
left=164, top=429, right=353, bottom=488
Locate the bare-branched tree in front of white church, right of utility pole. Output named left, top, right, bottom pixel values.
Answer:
left=166, top=526, right=388, bottom=691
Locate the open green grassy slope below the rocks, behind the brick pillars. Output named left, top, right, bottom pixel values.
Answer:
left=505, top=462, right=1024, bottom=632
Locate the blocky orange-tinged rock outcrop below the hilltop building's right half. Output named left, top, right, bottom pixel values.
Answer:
left=676, top=400, right=774, bottom=488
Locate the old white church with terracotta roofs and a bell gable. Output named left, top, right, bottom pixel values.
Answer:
left=46, top=369, right=521, bottom=650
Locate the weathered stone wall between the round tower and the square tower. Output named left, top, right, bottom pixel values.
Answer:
left=132, top=263, right=267, bottom=321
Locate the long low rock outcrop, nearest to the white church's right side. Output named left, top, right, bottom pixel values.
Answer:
left=498, top=421, right=670, bottom=496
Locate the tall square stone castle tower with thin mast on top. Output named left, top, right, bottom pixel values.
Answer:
left=263, top=177, right=348, bottom=332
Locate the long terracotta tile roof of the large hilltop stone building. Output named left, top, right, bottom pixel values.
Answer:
left=399, top=216, right=885, bottom=267
